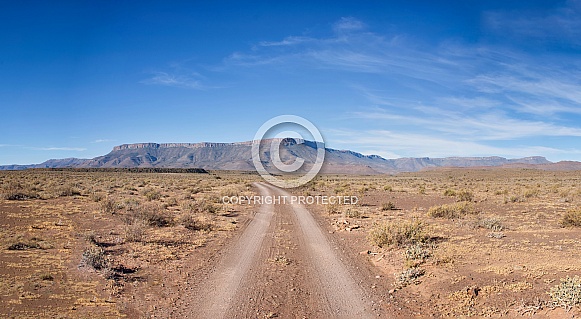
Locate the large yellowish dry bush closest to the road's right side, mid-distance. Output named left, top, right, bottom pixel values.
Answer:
left=367, top=220, right=428, bottom=248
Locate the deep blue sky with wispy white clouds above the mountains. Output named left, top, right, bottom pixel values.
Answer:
left=0, top=0, right=581, bottom=164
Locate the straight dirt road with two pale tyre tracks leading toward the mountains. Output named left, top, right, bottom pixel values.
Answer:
left=185, top=183, right=378, bottom=318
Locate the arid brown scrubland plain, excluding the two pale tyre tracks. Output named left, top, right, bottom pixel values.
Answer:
left=0, top=168, right=581, bottom=318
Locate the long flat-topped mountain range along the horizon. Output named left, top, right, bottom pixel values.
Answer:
left=0, top=139, right=568, bottom=174
